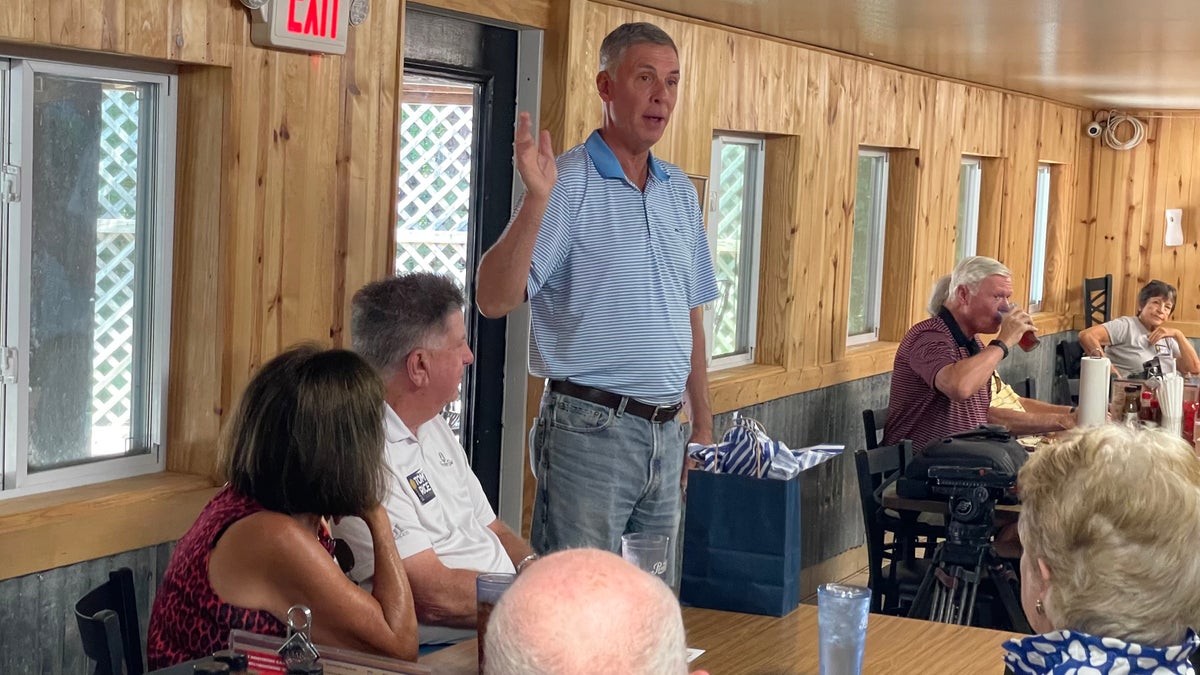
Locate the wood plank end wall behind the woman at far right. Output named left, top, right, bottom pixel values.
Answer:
left=1072, top=112, right=1200, bottom=338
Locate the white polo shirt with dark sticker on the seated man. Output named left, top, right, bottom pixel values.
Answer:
left=334, top=406, right=514, bottom=645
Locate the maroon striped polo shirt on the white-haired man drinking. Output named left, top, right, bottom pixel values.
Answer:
left=883, top=317, right=991, bottom=452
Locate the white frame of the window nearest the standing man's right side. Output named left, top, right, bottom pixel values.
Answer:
left=701, top=133, right=767, bottom=370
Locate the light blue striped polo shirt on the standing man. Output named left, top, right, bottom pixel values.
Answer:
left=526, top=132, right=718, bottom=404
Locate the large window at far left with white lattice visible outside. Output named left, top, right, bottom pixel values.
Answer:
left=0, top=59, right=175, bottom=496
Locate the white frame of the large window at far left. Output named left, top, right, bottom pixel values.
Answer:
left=0, top=58, right=178, bottom=500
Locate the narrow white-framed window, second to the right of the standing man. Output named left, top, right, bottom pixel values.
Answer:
left=846, top=148, right=888, bottom=345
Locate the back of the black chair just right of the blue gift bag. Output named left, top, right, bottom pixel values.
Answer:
left=854, top=439, right=912, bottom=613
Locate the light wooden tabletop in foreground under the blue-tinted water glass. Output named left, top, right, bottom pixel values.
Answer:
left=421, top=604, right=1019, bottom=675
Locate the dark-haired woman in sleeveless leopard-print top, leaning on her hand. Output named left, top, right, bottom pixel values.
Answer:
left=146, top=346, right=416, bottom=669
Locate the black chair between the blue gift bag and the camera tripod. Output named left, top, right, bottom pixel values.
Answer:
left=854, top=439, right=944, bottom=614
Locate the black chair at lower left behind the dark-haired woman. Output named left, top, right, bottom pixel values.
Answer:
left=76, top=567, right=145, bottom=675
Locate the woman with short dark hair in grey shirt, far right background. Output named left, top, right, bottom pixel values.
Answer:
left=1079, top=279, right=1200, bottom=377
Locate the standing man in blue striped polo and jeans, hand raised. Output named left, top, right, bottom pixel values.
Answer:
left=476, top=23, right=718, bottom=552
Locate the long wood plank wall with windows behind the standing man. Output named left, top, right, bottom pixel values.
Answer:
left=547, top=0, right=1090, bottom=413
